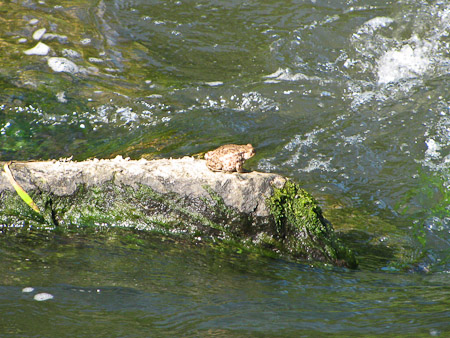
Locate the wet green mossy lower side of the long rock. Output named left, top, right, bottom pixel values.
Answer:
left=0, top=181, right=356, bottom=267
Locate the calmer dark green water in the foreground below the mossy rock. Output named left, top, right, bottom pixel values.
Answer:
left=0, top=230, right=448, bottom=337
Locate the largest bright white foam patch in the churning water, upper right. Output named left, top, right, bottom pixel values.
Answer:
left=378, top=45, right=431, bottom=84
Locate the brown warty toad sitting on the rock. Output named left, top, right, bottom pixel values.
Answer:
left=205, top=144, right=255, bottom=173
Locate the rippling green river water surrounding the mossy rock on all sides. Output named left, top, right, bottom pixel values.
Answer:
left=0, top=0, right=450, bottom=337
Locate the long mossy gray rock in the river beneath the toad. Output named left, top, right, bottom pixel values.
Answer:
left=0, top=157, right=356, bottom=267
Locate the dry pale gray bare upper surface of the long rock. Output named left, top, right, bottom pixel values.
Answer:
left=0, top=156, right=286, bottom=216
